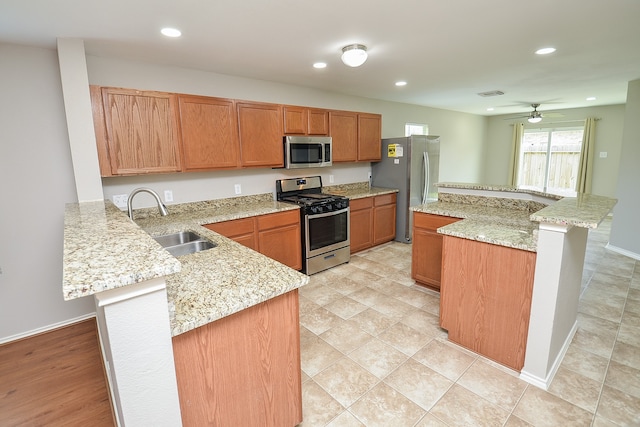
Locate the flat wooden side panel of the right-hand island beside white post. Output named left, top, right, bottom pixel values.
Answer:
left=440, top=236, right=536, bottom=371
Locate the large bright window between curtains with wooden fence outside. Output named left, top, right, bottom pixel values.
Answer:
left=518, top=128, right=584, bottom=191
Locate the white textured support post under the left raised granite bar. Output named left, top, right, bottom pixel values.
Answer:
left=95, top=278, right=182, bottom=427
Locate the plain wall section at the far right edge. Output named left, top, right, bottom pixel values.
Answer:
left=609, top=80, right=640, bottom=259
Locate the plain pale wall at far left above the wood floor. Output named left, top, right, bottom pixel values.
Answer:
left=0, top=44, right=95, bottom=342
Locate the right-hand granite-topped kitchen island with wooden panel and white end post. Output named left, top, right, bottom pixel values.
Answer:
left=412, top=183, right=616, bottom=388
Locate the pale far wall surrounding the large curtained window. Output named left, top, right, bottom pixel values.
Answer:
left=483, top=105, right=625, bottom=197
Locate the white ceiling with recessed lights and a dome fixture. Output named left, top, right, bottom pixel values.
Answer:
left=0, top=0, right=640, bottom=115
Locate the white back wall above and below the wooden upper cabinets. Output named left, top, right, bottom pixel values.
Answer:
left=87, top=56, right=486, bottom=207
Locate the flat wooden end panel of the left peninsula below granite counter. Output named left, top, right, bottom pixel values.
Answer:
left=173, top=289, right=302, bottom=427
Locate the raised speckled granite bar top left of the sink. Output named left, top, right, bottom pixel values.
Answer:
left=62, top=201, right=180, bottom=300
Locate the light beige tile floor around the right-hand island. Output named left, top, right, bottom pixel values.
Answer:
left=300, top=220, right=640, bottom=427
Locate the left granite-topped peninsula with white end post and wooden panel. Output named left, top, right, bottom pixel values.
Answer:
left=63, top=194, right=309, bottom=426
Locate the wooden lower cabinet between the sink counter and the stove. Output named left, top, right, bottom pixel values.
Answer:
left=204, top=209, right=302, bottom=270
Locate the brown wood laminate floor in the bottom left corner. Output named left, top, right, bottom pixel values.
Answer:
left=0, top=319, right=115, bottom=427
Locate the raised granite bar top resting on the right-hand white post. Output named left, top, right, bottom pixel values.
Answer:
left=530, top=194, right=618, bottom=228
